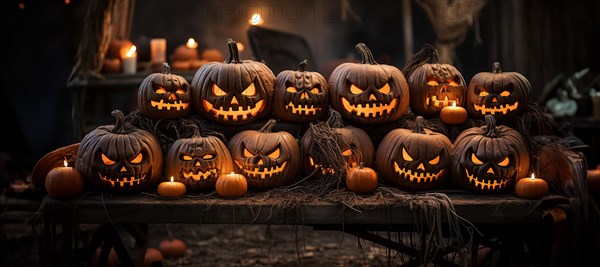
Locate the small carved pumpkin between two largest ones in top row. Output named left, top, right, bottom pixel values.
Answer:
left=273, top=60, right=329, bottom=122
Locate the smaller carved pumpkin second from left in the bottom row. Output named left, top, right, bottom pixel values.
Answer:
left=165, top=125, right=235, bottom=191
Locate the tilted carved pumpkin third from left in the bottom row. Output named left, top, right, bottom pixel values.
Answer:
left=227, top=119, right=300, bottom=188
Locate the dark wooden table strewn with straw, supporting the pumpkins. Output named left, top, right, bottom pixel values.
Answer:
left=41, top=190, right=564, bottom=266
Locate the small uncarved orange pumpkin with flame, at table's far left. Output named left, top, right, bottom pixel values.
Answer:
left=45, top=160, right=84, bottom=198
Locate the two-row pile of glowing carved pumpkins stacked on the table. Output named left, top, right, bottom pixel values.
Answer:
left=41, top=40, right=576, bottom=201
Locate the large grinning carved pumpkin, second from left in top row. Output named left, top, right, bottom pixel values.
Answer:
left=192, top=39, right=275, bottom=125
